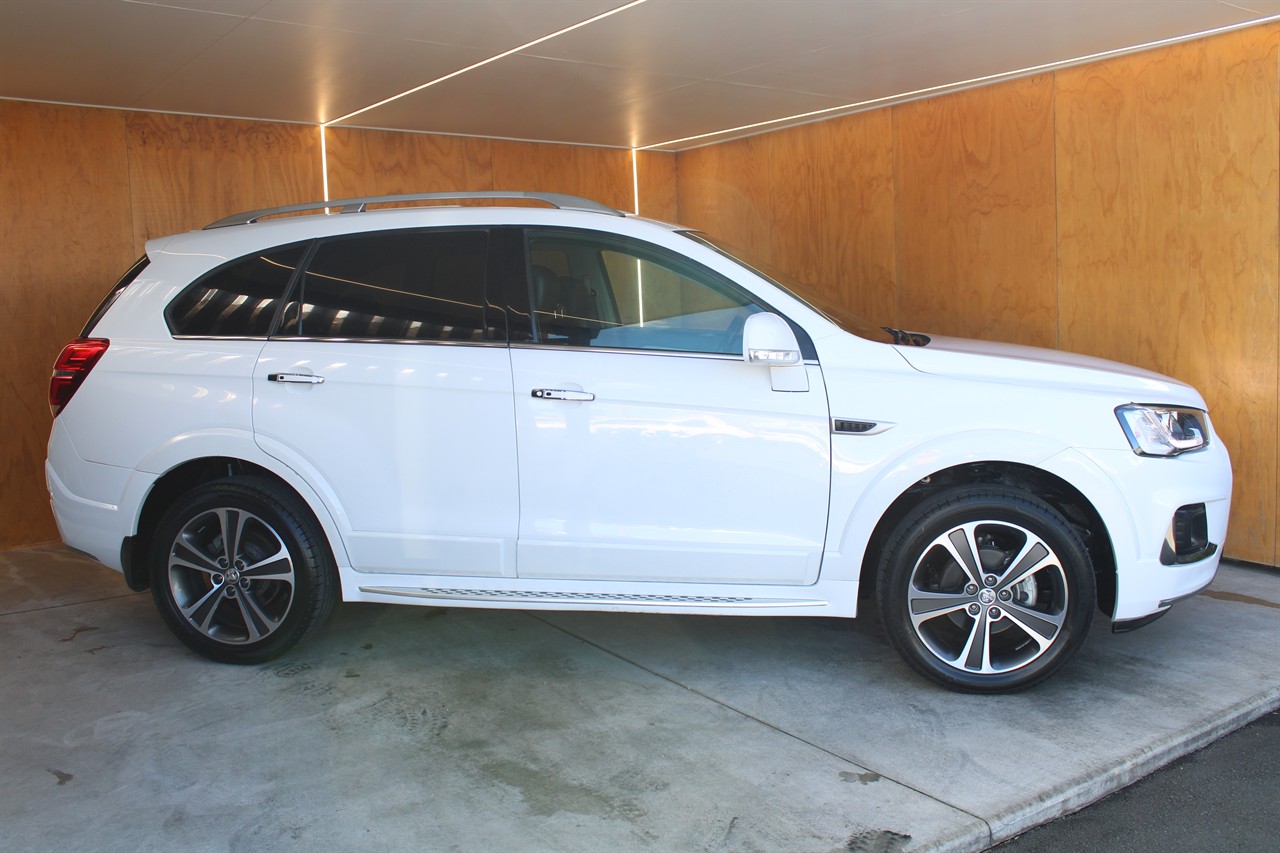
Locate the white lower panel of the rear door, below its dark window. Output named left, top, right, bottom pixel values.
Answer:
left=253, top=341, right=520, bottom=576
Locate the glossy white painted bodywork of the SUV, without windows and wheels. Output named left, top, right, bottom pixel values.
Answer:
left=46, top=201, right=1230, bottom=637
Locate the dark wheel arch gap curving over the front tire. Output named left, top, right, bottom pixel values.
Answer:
left=859, top=461, right=1116, bottom=615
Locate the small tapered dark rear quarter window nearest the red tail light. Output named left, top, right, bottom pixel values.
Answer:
left=168, top=243, right=307, bottom=338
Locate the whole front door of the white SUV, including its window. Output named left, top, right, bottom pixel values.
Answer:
left=511, top=231, right=831, bottom=584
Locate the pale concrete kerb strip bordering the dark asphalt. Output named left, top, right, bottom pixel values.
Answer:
left=967, top=685, right=1280, bottom=853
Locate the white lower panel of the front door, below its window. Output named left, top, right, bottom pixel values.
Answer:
left=511, top=347, right=831, bottom=584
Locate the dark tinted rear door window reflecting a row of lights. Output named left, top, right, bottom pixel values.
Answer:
left=279, top=231, right=491, bottom=341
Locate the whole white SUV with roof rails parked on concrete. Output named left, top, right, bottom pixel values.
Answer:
left=46, top=192, right=1231, bottom=692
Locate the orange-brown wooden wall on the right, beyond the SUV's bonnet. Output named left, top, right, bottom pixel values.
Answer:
left=676, top=24, right=1280, bottom=565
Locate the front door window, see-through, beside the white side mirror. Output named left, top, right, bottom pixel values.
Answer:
left=529, top=232, right=762, bottom=355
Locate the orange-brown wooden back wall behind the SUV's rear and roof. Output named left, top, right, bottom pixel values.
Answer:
left=0, top=101, right=660, bottom=547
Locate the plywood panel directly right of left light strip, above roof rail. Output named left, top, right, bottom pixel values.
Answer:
left=325, top=128, right=494, bottom=199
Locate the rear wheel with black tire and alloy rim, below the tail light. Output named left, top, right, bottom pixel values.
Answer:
left=150, top=476, right=338, bottom=663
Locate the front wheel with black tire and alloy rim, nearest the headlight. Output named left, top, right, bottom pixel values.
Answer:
left=877, top=485, right=1097, bottom=693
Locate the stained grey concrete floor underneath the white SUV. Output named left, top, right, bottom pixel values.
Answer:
left=0, top=546, right=1280, bottom=852
